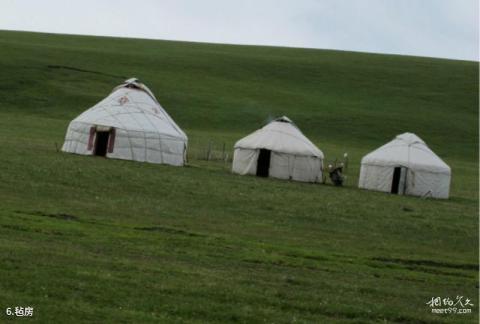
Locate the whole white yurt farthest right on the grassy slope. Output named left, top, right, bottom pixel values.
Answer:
left=358, top=133, right=451, bottom=198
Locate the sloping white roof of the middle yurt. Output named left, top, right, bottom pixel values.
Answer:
left=235, top=116, right=323, bottom=158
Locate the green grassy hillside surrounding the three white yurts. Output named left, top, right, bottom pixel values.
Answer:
left=0, top=31, right=479, bottom=323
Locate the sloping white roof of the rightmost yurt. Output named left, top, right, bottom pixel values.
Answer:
left=362, top=133, right=450, bottom=173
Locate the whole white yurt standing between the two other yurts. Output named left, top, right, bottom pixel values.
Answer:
left=232, top=116, right=323, bottom=182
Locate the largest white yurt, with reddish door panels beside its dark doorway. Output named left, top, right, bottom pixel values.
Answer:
left=62, top=79, right=188, bottom=166
